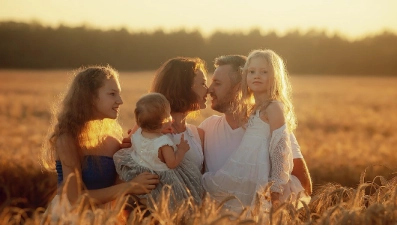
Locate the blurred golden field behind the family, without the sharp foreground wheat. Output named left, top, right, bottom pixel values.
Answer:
left=0, top=70, right=397, bottom=208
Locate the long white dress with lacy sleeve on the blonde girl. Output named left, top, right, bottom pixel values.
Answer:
left=203, top=111, right=310, bottom=212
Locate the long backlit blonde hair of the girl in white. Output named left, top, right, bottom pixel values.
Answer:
left=242, top=49, right=297, bottom=132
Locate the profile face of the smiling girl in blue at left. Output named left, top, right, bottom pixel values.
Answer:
left=94, top=78, right=123, bottom=119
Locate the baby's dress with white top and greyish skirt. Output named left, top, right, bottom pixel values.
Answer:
left=113, top=128, right=204, bottom=209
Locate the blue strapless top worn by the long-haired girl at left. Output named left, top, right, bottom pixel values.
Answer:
left=55, top=155, right=117, bottom=190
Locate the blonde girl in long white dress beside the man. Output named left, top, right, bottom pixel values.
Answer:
left=203, top=50, right=310, bottom=212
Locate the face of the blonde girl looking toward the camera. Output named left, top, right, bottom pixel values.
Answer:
left=247, top=57, right=273, bottom=95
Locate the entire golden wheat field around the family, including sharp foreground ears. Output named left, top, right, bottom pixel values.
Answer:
left=0, top=70, right=397, bottom=224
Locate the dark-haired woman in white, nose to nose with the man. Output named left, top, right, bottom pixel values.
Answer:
left=150, top=57, right=208, bottom=171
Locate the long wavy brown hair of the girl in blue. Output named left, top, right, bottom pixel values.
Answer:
left=42, top=66, right=122, bottom=168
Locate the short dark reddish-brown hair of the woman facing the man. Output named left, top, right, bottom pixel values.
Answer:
left=150, top=57, right=207, bottom=113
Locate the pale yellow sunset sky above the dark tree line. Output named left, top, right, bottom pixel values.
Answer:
left=0, top=0, right=397, bottom=38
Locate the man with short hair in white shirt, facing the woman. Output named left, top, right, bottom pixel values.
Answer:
left=199, top=55, right=312, bottom=195
